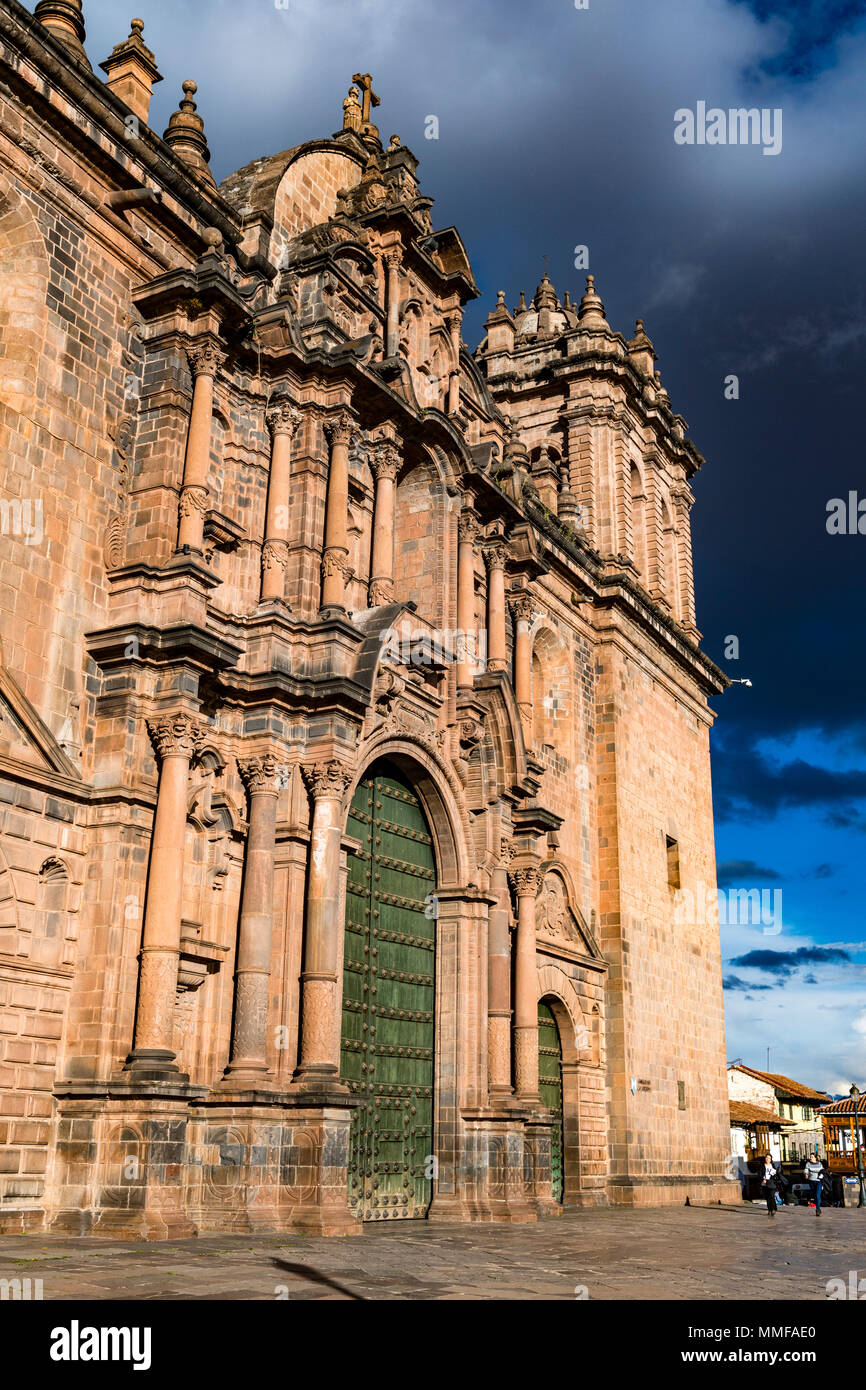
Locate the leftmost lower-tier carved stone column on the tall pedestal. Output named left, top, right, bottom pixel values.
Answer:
left=126, top=712, right=207, bottom=1073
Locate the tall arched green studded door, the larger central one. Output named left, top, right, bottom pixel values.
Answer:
left=341, top=762, right=436, bottom=1220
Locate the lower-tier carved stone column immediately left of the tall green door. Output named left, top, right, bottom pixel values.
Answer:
left=295, top=760, right=352, bottom=1088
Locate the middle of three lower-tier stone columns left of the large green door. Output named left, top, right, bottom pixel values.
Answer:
left=225, top=753, right=286, bottom=1084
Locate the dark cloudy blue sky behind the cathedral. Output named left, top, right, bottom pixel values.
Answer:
left=69, top=0, right=866, bottom=1091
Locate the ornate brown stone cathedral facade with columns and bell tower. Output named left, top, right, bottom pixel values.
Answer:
left=0, top=0, right=733, bottom=1238
